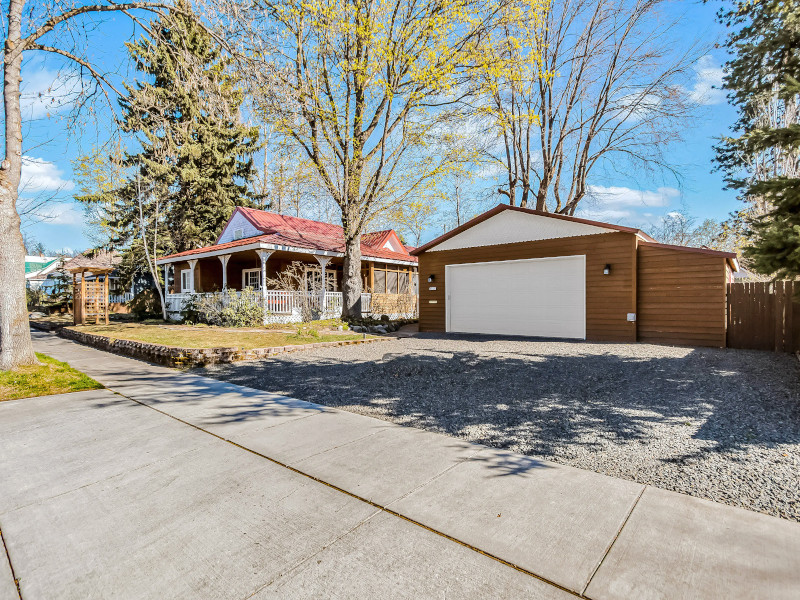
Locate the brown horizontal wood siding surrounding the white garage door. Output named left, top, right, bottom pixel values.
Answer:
left=419, top=232, right=636, bottom=342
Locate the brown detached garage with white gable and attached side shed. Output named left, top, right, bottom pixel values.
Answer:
left=411, top=204, right=738, bottom=346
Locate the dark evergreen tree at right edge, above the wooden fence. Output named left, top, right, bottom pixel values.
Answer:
left=717, top=0, right=800, bottom=278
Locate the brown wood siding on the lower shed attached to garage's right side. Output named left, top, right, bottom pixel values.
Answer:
left=637, top=244, right=727, bottom=347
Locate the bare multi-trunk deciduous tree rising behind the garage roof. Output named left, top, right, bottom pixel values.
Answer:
left=481, top=0, right=700, bottom=215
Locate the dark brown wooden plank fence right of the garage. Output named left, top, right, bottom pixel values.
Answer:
left=727, top=281, right=800, bottom=352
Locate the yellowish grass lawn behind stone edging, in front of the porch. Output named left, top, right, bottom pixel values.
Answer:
left=70, top=322, right=363, bottom=350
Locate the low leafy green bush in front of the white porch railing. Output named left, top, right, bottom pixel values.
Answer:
left=181, top=288, right=264, bottom=327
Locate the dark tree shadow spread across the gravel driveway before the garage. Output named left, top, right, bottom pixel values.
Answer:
left=197, top=336, right=800, bottom=460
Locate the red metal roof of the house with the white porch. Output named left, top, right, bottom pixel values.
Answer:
left=162, top=207, right=417, bottom=262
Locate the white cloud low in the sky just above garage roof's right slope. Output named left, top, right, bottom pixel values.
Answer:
left=578, top=185, right=681, bottom=224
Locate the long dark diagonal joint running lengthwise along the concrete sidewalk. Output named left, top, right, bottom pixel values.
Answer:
left=109, top=388, right=584, bottom=598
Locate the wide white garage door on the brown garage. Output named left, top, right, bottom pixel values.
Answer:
left=445, top=256, right=586, bottom=339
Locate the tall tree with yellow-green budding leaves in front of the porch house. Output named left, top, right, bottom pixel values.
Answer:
left=203, top=0, right=538, bottom=316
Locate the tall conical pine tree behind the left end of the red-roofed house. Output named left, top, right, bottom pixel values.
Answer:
left=111, top=0, right=258, bottom=252
